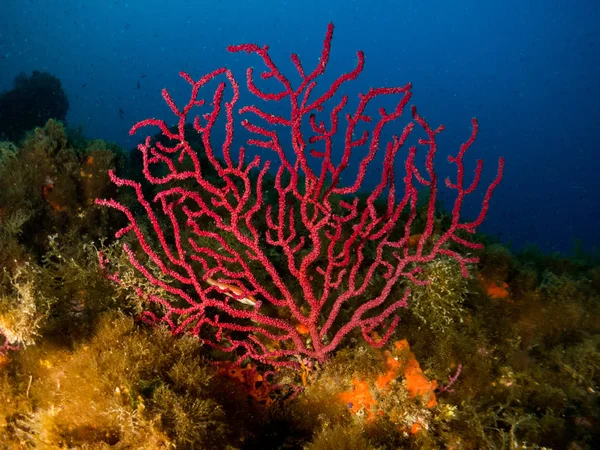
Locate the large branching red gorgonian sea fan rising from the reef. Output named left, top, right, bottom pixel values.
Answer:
left=97, top=24, right=504, bottom=365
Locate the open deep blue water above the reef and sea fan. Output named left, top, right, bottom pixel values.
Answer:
left=0, top=0, right=600, bottom=252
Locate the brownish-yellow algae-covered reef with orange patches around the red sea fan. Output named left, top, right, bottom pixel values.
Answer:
left=0, top=120, right=600, bottom=450
